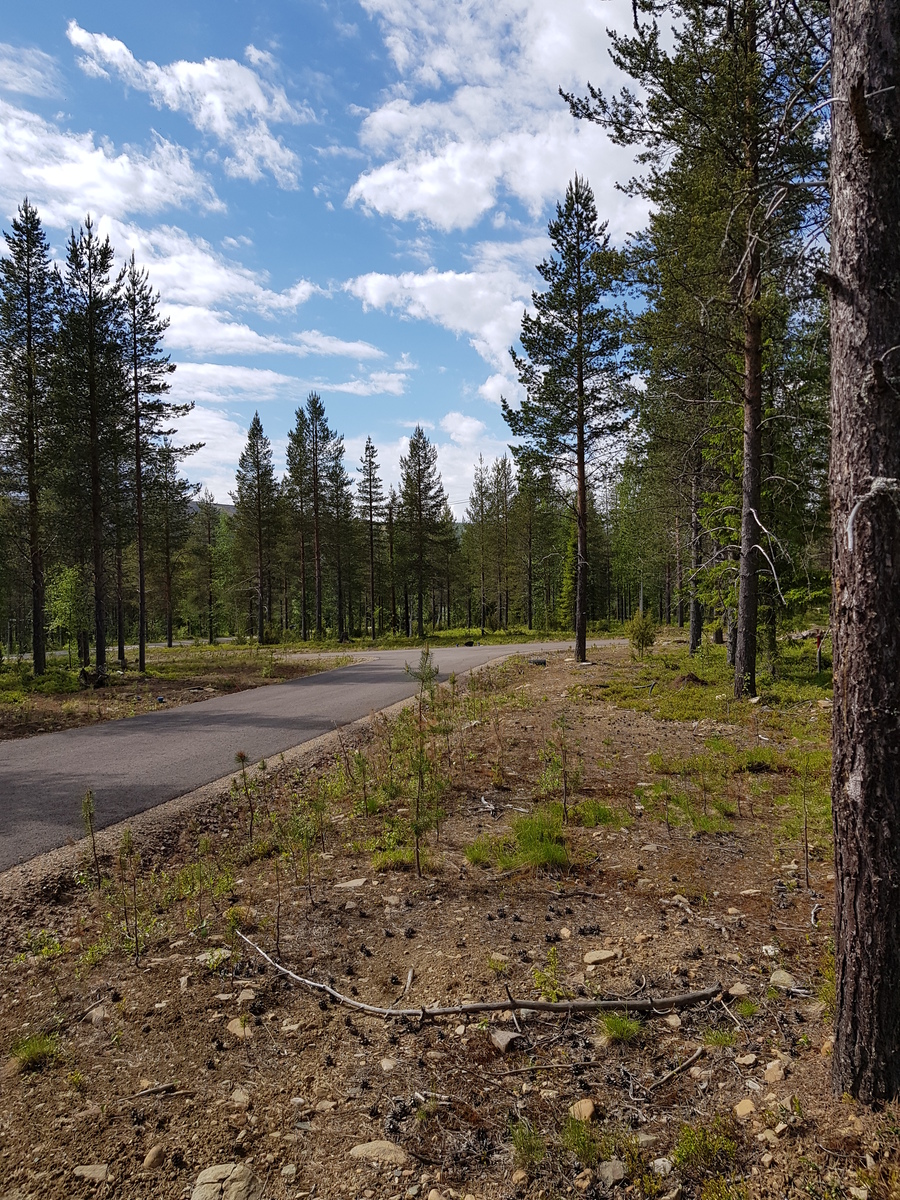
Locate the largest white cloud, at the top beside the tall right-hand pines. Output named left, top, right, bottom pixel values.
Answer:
left=348, top=0, right=637, bottom=238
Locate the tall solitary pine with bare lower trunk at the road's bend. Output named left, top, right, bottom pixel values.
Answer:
left=503, top=175, right=623, bottom=662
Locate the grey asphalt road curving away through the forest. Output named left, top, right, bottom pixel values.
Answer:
left=0, top=642, right=600, bottom=871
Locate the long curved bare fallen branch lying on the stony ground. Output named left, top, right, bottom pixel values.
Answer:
left=236, top=930, right=722, bottom=1020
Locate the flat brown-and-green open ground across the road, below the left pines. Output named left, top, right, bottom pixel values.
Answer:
left=0, top=646, right=348, bottom=740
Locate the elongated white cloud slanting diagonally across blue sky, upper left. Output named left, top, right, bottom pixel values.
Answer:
left=66, top=20, right=313, bottom=187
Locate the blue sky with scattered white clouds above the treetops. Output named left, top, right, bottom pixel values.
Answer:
left=0, top=0, right=641, bottom=512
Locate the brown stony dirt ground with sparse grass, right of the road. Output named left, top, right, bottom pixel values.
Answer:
left=0, top=647, right=900, bottom=1200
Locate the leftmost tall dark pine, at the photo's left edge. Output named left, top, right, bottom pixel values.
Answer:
left=0, top=199, right=58, bottom=676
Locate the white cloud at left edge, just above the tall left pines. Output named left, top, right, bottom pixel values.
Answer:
left=0, top=100, right=223, bottom=228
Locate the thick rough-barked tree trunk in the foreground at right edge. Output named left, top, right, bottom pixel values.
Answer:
left=830, top=0, right=900, bottom=1103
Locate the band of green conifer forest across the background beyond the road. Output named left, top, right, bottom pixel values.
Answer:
left=0, top=179, right=828, bottom=672
